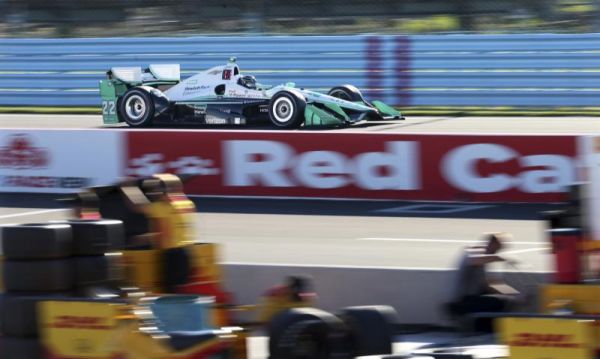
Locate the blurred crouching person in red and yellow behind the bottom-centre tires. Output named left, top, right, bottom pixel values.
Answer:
left=258, top=275, right=316, bottom=323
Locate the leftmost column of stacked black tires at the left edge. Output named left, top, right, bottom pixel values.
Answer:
left=0, top=223, right=73, bottom=359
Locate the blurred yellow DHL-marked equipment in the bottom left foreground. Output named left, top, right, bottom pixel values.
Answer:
left=39, top=301, right=247, bottom=359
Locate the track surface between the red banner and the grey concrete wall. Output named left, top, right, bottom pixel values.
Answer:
left=0, top=194, right=557, bottom=270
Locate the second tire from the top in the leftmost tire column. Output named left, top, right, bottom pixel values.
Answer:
left=2, top=259, right=73, bottom=292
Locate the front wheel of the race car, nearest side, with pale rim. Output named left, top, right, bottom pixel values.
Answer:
left=269, top=90, right=306, bottom=129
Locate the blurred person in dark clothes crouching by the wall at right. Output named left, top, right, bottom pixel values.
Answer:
left=447, top=233, right=519, bottom=331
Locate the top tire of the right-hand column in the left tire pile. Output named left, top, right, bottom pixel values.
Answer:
left=59, top=219, right=125, bottom=256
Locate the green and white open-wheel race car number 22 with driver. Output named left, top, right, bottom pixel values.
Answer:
left=100, top=58, right=404, bottom=129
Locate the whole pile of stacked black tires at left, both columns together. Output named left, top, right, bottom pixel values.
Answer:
left=0, top=220, right=124, bottom=359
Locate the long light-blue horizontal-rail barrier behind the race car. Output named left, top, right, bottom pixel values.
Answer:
left=0, top=34, right=600, bottom=107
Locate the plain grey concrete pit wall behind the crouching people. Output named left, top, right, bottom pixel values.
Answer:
left=223, top=264, right=548, bottom=324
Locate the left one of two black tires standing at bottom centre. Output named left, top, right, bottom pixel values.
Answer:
left=268, top=308, right=352, bottom=359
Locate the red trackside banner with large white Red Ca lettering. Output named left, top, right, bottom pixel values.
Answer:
left=127, top=130, right=576, bottom=202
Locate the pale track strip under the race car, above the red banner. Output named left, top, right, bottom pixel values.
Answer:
left=0, top=114, right=600, bottom=134
